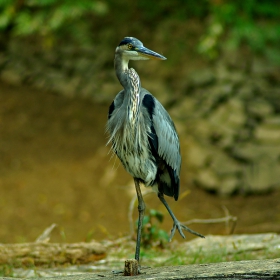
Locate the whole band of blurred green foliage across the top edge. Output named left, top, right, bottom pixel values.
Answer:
left=0, top=0, right=280, bottom=64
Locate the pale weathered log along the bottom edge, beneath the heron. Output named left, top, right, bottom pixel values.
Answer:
left=0, top=259, right=280, bottom=280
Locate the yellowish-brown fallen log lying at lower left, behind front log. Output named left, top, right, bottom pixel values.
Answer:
left=0, top=241, right=106, bottom=266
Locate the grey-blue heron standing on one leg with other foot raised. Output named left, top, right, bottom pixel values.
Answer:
left=106, top=37, right=204, bottom=263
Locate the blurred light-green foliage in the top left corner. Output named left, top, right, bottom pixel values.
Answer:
left=0, top=0, right=107, bottom=44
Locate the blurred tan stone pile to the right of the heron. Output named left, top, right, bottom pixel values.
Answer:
left=172, top=57, right=280, bottom=195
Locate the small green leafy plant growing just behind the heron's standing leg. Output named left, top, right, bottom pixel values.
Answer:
left=136, top=209, right=168, bottom=248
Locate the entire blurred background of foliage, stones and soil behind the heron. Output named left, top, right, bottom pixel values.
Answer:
left=0, top=0, right=280, bottom=242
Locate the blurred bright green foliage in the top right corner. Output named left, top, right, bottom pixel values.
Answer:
left=198, top=0, right=280, bottom=64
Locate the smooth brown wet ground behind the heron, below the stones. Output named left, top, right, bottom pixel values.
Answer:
left=0, top=83, right=280, bottom=243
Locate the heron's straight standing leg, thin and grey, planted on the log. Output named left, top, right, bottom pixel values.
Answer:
left=134, top=178, right=145, bottom=264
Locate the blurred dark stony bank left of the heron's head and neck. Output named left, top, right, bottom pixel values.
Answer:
left=0, top=39, right=117, bottom=101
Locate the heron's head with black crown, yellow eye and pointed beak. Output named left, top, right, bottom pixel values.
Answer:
left=116, top=37, right=166, bottom=61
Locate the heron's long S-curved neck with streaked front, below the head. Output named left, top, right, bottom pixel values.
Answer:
left=115, top=53, right=141, bottom=124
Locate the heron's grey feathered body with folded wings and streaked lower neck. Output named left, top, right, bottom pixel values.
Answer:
left=107, top=68, right=181, bottom=200
